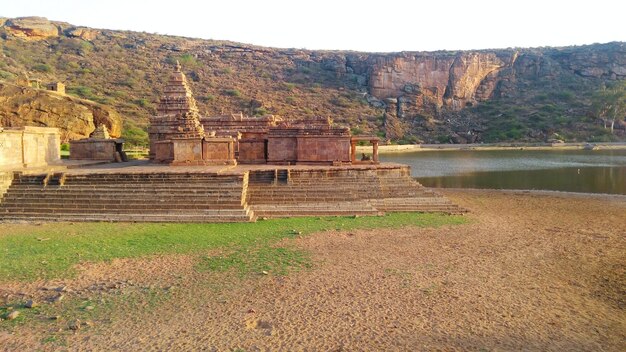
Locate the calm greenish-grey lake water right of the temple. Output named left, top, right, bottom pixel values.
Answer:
left=380, top=150, right=626, bottom=194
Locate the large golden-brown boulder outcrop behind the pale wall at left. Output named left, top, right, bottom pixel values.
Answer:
left=0, top=82, right=122, bottom=142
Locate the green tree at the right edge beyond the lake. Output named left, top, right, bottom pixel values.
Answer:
left=591, top=81, right=626, bottom=133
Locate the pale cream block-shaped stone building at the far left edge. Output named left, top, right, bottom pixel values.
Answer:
left=0, top=126, right=61, bottom=171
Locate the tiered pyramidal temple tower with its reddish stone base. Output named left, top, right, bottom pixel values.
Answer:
left=148, top=62, right=236, bottom=165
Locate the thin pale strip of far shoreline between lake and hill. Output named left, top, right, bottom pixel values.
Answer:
left=357, top=142, right=626, bottom=154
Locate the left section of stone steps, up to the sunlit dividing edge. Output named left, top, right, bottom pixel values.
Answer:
left=0, top=173, right=256, bottom=222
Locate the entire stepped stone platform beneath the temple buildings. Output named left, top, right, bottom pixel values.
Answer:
left=0, top=161, right=465, bottom=222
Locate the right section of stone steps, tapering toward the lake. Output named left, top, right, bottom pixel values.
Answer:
left=248, top=168, right=466, bottom=217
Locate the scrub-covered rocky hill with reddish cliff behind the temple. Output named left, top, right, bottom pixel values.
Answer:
left=0, top=17, right=626, bottom=144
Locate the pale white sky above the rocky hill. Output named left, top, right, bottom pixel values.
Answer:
left=0, top=0, right=626, bottom=52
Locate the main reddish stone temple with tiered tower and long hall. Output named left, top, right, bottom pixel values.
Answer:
left=148, top=63, right=378, bottom=165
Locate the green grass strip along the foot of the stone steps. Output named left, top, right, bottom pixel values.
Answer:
left=0, top=213, right=467, bottom=281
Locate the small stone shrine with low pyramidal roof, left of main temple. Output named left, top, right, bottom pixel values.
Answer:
left=70, top=125, right=127, bottom=162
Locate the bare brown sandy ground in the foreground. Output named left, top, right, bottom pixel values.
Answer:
left=0, top=191, right=626, bottom=351
